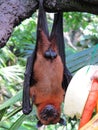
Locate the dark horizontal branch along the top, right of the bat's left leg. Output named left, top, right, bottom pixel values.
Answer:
left=45, top=0, right=98, bottom=14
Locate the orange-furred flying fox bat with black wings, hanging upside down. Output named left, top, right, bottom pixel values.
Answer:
left=22, top=0, right=71, bottom=126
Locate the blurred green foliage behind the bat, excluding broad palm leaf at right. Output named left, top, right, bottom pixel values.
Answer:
left=0, top=12, right=98, bottom=130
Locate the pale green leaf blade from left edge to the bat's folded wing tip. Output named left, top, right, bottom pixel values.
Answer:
left=0, top=90, right=22, bottom=110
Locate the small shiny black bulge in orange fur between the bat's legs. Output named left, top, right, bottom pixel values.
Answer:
left=44, top=48, right=57, bottom=59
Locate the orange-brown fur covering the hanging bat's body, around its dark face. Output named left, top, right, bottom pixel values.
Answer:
left=30, top=31, right=64, bottom=124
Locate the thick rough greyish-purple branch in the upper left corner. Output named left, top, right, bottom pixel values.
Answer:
left=0, top=0, right=38, bottom=48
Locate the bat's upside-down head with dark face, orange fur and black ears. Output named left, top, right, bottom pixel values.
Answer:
left=37, top=105, right=65, bottom=127
